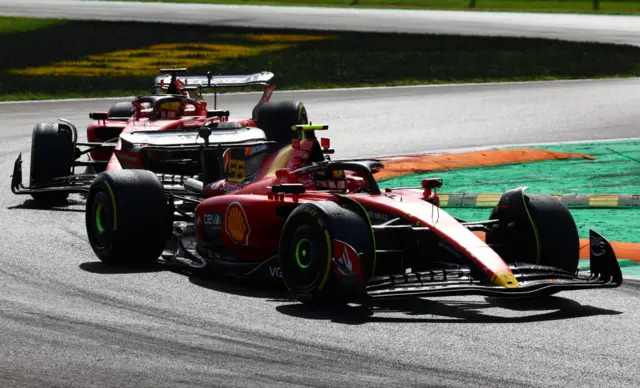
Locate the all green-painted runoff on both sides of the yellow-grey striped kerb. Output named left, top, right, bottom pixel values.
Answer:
left=380, top=140, right=640, bottom=243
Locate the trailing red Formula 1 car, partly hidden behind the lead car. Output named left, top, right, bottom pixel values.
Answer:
left=12, top=69, right=308, bottom=202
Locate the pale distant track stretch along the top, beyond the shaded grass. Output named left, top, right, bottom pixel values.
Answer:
left=0, top=0, right=640, bottom=45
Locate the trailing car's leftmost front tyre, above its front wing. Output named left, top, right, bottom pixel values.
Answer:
left=29, top=123, right=75, bottom=202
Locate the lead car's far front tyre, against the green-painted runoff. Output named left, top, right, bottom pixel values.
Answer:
left=486, top=188, right=580, bottom=273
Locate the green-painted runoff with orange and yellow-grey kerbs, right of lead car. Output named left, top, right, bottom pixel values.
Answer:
left=376, top=139, right=640, bottom=276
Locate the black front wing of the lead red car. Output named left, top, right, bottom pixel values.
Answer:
left=366, top=230, right=622, bottom=299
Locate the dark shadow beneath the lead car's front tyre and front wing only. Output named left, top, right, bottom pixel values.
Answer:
left=276, top=296, right=622, bottom=325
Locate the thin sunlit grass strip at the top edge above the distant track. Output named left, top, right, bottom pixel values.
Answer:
left=112, top=0, right=640, bottom=14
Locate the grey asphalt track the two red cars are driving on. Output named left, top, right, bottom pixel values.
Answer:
left=0, top=1, right=640, bottom=387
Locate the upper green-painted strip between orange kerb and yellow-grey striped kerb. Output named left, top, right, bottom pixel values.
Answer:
left=381, top=140, right=640, bottom=194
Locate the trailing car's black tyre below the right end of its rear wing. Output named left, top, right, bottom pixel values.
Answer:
left=257, top=101, right=309, bottom=145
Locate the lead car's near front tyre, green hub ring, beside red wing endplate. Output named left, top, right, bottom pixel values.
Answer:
left=279, top=201, right=375, bottom=305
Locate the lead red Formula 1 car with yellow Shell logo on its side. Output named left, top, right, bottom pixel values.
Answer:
left=77, top=125, right=622, bottom=304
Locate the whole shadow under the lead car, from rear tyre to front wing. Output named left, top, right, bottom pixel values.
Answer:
left=80, top=255, right=622, bottom=325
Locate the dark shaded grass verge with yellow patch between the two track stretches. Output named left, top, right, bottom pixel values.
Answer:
left=0, top=18, right=640, bottom=100
